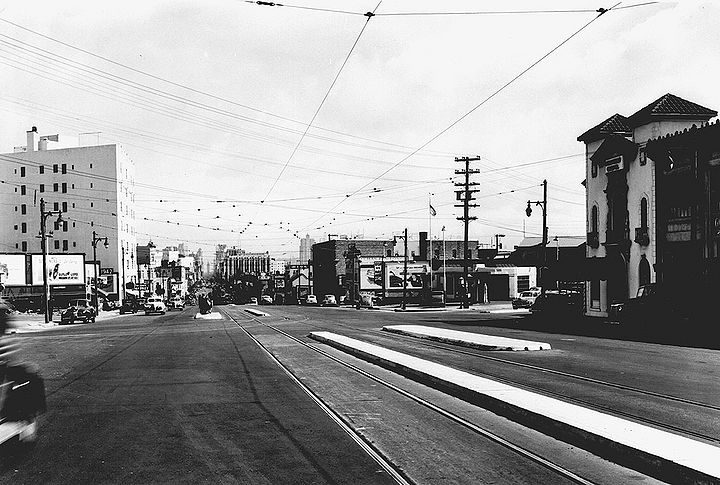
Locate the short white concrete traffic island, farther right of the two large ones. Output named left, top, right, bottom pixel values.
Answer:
left=382, top=325, right=551, bottom=351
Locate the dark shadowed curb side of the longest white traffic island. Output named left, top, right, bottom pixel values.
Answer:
left=309, top=332, right=720, bottom=484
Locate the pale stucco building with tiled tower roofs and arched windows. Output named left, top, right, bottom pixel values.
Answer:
left=578, top=94, right=717, bottom=316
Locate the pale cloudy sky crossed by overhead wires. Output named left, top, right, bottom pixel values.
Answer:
left=0, top=0, right=720, bottom=259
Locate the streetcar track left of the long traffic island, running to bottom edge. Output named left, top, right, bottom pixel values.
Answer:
left=225, top=312, right=594, bottom=485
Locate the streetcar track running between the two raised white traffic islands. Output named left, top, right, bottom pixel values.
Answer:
left=253, top=310, right=720, bottom=443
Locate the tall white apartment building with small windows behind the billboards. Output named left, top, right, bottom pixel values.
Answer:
left=0, top=127, right=137, bottom=290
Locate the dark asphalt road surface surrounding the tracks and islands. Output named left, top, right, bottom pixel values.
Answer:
left=0, top=305, right=720, bottom=484
